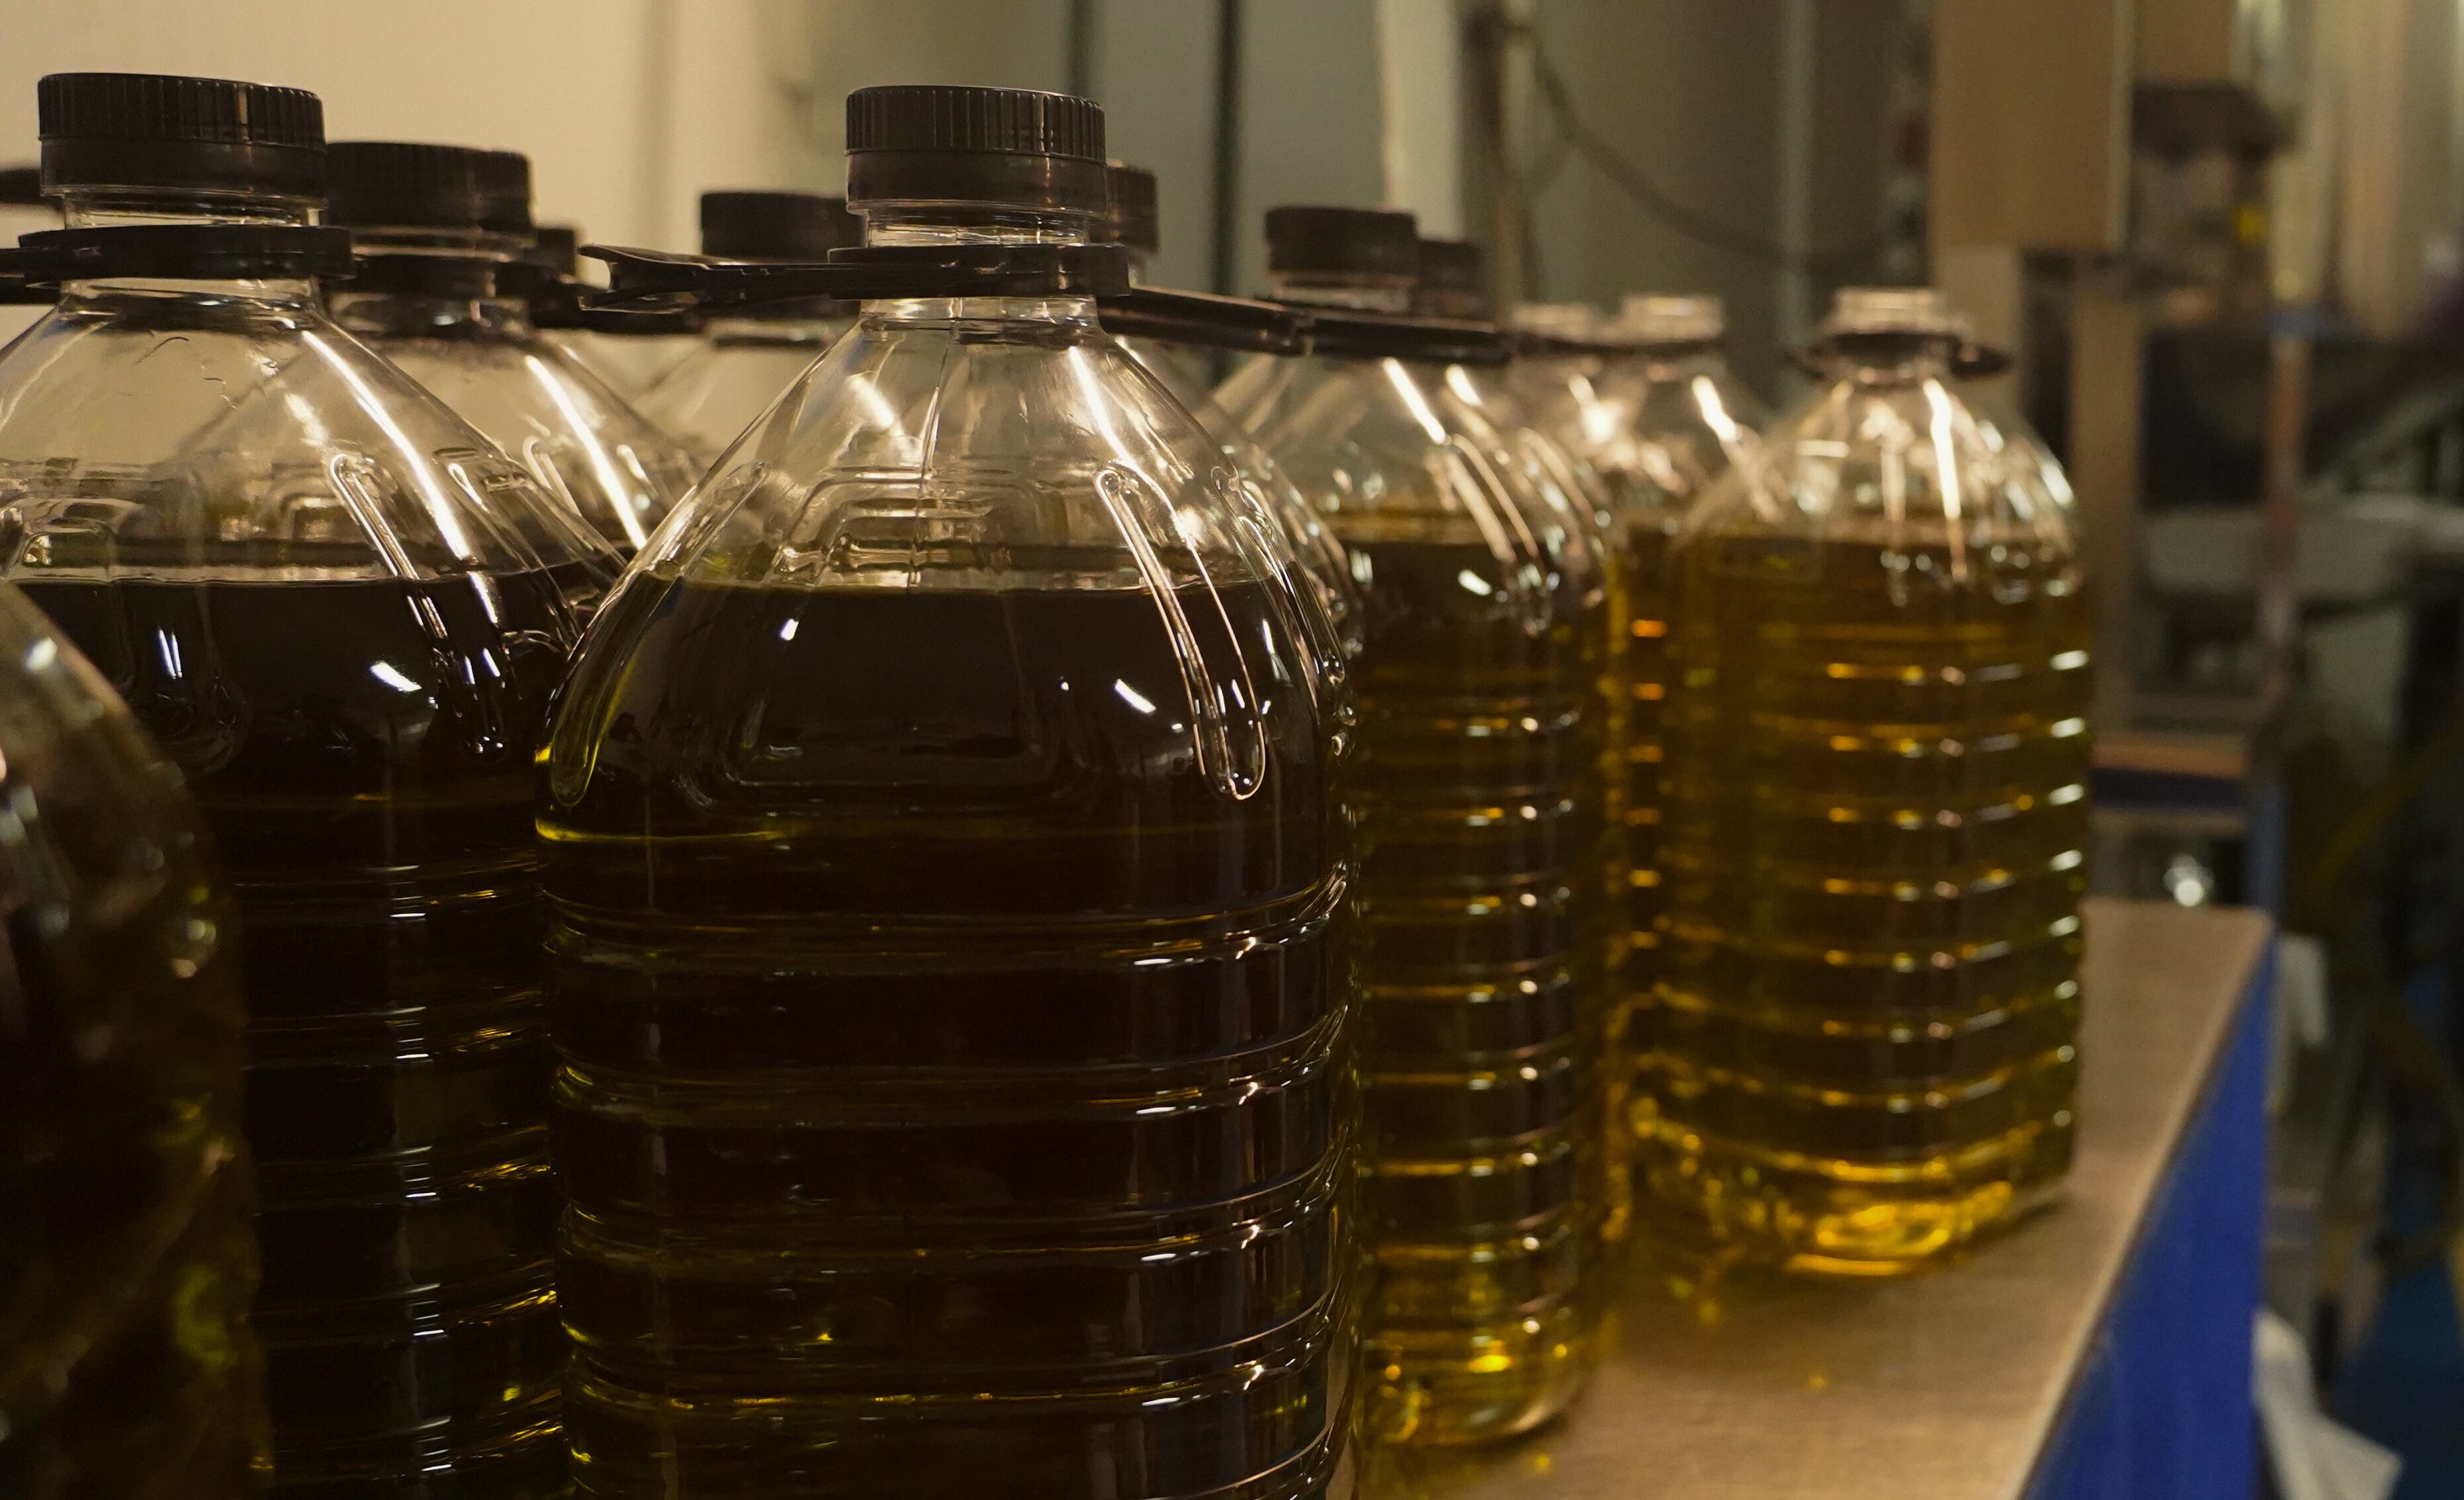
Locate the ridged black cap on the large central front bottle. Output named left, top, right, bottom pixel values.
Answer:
left=848, top=84, right=1107, bottom=214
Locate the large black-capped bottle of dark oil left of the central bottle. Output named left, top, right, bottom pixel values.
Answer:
left=0, top=74, right=614, bottom=1500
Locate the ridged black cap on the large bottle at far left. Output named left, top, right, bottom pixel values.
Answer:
left=34, top=74, right=325, bottom=202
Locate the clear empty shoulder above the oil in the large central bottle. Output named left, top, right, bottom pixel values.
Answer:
left=658, top=320, right=1289, bottom=589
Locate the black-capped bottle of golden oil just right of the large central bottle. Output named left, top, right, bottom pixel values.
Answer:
left=1227, top=207, right=1609, bottom=1443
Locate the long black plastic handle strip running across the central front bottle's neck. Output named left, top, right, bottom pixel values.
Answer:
left=582, top=244, right=1513, bottom=365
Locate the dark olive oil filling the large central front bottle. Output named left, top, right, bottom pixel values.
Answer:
left=542, top=559, right=1357, bottom=1500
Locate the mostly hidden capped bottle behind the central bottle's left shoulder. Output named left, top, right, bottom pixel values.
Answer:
left=641, top=192, right=865, bottom=468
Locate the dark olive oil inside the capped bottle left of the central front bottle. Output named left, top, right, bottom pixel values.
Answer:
left=24, top=569, right=574, bottom=1497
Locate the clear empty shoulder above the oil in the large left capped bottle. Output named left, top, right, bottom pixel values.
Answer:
left=0, top=298, right=621, bottom=576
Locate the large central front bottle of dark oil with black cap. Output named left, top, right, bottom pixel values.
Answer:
left=542, top=86, right=1357, bottom=1500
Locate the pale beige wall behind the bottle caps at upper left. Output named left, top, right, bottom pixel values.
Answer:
left=0, top=0, right=828, bottom=249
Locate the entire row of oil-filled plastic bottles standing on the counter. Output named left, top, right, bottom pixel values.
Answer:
left=0, top=74, right=2087, bottom=1500
